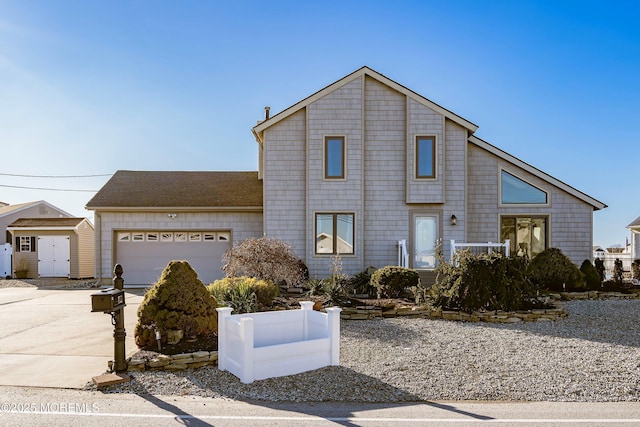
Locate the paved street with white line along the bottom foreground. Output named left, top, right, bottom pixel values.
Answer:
left=0, top=387, right=640, bottom=427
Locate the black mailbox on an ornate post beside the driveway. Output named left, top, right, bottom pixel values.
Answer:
left=91, top=264, right=127, bottom=372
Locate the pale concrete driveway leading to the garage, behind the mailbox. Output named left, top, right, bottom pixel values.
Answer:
left=0, top=288, right=143, bottom=389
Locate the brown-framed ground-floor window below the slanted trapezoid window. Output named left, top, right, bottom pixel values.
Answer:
left=500, top=216, right=548, bottom=259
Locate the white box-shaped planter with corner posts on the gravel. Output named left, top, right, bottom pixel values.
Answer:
left=216, top=301, right=341, bottom=384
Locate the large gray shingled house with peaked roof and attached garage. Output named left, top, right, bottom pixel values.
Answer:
left=87, top=67, right=606, bottom=284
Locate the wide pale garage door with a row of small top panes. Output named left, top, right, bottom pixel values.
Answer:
left=116, top=231, right=231, bottom=286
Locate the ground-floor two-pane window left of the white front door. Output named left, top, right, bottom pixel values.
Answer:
left=315, top=213, right=354, bottom=255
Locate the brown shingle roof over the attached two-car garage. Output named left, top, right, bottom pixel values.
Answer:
left=87, top=170, right=262, bottom=209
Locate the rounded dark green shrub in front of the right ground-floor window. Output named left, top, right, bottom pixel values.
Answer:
left=527, top=248, right=584, bottom=291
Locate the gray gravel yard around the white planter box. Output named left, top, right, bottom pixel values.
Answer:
left=86, top=300, right=640, bottom=402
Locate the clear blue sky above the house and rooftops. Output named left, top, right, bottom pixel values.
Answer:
left=0, top=0, right=640, bottom=246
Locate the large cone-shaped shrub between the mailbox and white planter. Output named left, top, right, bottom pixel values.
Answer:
left=134, top=261, right=218, bottom=350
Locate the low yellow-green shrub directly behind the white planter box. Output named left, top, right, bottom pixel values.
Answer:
left=207, top=276, right=280, bottom=313
